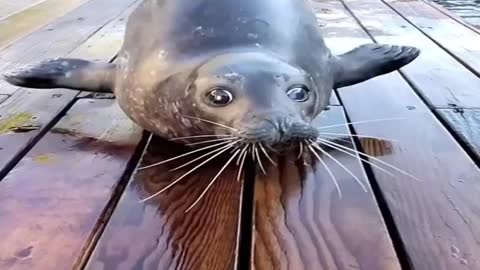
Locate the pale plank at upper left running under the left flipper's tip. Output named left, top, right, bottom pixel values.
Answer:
left=0, top=0, right=137, bottom=94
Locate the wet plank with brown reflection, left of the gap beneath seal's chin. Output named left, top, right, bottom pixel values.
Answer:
left=86, top=137, right=243, bottom=270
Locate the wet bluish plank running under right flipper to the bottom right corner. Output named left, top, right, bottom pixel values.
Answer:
left=315, top=1, right=480, bottom=270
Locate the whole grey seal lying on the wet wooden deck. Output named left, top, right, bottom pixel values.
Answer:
left=1, top=0, right=420, bottom=150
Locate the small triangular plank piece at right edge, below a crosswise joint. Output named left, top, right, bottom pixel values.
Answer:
left=437, top=109, right=480, bottom=160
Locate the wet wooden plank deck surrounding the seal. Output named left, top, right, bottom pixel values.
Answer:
left=0, top=0, right=480, bottom=270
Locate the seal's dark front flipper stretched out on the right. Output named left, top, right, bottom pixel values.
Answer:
left=334, top=44, right=420, bottom=88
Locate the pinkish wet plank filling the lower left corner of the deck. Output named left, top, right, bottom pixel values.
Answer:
left=0, top=99, right=142, bottom=270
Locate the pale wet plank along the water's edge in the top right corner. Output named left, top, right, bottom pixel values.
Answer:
left=385, top=0, right=480, bottom=77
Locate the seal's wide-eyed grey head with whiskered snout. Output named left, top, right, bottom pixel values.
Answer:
left=185, top=53, right=327, bottom=150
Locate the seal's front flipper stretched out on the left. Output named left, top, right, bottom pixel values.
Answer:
left=4, top=58, right=115, bottom=92
